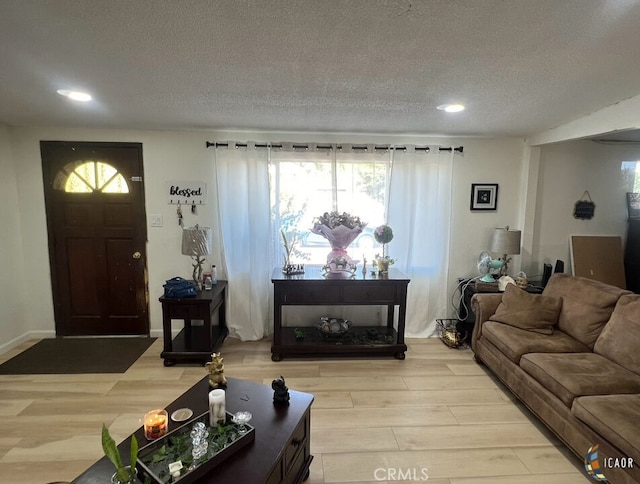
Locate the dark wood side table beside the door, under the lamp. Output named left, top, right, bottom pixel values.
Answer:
left=159, top=281, right=229, bottom=366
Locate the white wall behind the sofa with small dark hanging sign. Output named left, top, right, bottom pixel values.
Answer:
left=533, top=140, right=640, bottom=273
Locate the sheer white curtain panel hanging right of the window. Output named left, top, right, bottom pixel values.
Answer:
left=387, top=146, right=454, bottom=338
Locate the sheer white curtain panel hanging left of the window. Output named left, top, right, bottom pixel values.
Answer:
left=214, top=143, right=274, bottom=341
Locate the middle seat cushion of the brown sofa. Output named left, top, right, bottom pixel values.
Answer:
left=520, top=353, right=640, bottom=408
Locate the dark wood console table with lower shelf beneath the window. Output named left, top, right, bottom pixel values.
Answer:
left=271, top=266, right=409, bottom=361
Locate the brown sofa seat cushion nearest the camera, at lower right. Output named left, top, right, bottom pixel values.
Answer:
left=571, top=394, right=640, bottom=465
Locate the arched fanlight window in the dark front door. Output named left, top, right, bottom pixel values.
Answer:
left=53, top=161, right=129, bottom=193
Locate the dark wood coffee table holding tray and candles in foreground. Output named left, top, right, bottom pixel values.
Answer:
left=73, top=376, right=313, bottom=484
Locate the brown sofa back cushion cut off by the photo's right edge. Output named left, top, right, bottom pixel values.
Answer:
left=593, top=294, right=640, bottom=375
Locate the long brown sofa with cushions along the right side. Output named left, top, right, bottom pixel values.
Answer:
left=471, top=274, right=640, bottom=484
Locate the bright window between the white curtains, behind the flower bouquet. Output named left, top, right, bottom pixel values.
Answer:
left=269, top=150, right=389, bottom=265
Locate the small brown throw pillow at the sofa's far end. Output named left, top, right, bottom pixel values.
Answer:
left=491, top=284, right=562, bottom=334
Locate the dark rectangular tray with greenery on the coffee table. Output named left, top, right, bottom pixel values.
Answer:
left=136, top=411, right=255, bottom=484
